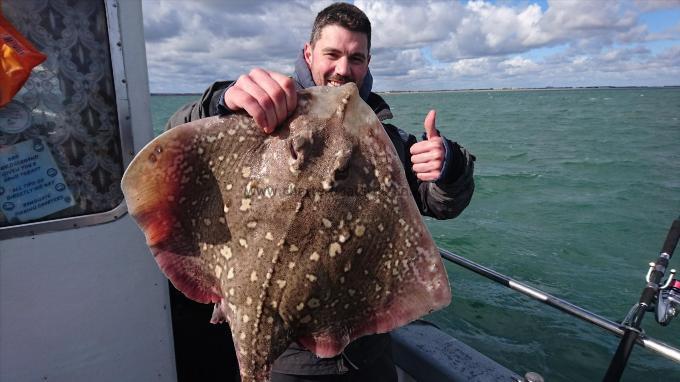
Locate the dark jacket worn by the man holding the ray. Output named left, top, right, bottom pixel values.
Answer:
left=166, top=78, right=475, bottom=375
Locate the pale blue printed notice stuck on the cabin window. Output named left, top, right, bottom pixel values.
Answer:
left=0, top=138, right=75, bottom=223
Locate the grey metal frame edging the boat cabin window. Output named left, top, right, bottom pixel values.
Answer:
left=0, top=0, right=134, bottom=240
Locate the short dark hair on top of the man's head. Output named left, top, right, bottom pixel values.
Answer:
left=309, top=3, right=371, bottom=52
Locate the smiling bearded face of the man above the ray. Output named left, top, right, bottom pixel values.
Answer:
left=305, top=25, right=371, bottom=89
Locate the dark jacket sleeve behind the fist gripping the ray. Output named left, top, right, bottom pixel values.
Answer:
left=165, top=81, right=232, bottom=130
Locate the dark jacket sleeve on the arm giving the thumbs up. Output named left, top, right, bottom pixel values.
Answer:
left=385, top=125, right=475, bottom=219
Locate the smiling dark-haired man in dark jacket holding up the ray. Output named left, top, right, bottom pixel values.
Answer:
left=166, top=3, right=474, bottom=382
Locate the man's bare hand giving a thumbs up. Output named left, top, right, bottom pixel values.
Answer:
left=411, top=110, right=446, bottom=182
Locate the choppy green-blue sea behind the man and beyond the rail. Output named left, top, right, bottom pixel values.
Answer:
left=151, top=88, right=680, bottom=382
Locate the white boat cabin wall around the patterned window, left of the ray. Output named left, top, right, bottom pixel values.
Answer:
left=0, top=0, right=176, bottom=382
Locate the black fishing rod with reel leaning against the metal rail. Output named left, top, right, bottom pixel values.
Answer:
left=603, top=217, right=680, bottom=382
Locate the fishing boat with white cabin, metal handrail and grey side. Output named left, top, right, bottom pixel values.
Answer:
left=0, top=0, right=680, bottom=382
